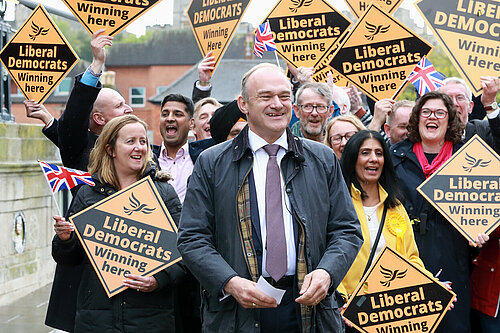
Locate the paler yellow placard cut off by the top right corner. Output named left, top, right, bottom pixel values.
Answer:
left=415, top=0, right=500, bottom=96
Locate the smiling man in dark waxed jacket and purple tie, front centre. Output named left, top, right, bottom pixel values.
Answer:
left=178, top=64, right=362, bottom=333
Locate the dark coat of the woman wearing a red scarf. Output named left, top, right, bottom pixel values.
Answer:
left=391, top=139, right=471, bottom=333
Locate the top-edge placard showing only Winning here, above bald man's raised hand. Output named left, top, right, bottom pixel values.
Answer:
left=62, top=0, right=162, bottom=36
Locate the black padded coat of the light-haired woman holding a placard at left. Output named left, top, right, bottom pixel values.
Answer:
left=52, top=171, right=186, bottom=332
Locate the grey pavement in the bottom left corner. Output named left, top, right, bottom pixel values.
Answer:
left=0, top=284, right=64, bottom=333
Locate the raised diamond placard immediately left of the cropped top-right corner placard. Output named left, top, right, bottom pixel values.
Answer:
left=330, top=4, right=433, bottom=101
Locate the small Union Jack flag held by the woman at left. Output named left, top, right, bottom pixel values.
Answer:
left=38, top=161, right=95, bottom=193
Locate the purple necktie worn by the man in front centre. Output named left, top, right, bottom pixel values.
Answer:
left=263, top=144, right=287, bottom=281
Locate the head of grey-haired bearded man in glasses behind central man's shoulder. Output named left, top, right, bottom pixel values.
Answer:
left=293, top=82, right=333, bottom=142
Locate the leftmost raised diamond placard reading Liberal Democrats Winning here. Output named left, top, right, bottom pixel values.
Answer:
left=0, top=5, right=79, bottom=103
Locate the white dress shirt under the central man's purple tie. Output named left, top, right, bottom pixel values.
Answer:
left=248, top=130, right=296, bottom=277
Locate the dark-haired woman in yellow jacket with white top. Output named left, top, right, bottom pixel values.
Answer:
left=338, top=130, right=430, bottom=297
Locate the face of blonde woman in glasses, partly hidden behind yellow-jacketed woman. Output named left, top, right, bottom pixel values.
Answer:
left=324, top=114, right=366, bottom=160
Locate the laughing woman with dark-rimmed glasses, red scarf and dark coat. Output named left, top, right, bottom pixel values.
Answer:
left=391, top=91, right=470, bottom=333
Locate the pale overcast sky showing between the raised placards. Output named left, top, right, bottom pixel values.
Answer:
left=24, top=0, right=421, bottom=35
